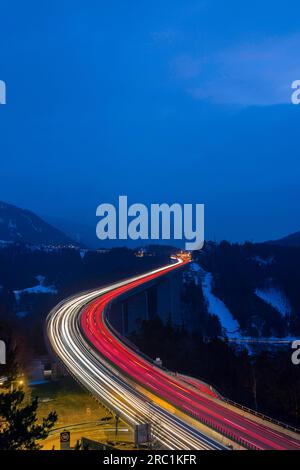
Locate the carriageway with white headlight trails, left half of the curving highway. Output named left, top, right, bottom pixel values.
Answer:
left=47, top=258, right=224, bottom=450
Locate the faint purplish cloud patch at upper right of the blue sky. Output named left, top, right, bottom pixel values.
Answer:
left=172, top=34, right=300, bottom=105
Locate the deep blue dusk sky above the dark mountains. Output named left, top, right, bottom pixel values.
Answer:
left=0, top=0, right=300, bottom=241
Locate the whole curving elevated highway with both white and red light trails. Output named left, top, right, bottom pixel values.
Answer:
left=47, top=260, right=300, bottom=450
